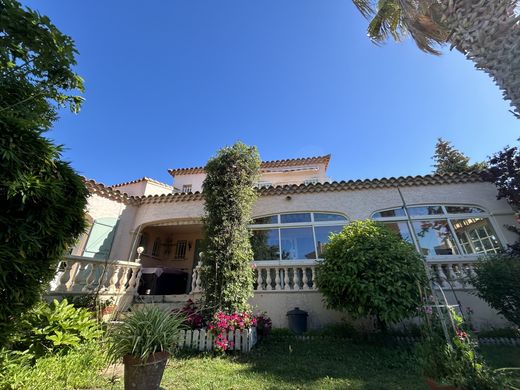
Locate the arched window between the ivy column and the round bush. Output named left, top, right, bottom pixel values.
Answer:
left=250, top=212, right=348, bottom=261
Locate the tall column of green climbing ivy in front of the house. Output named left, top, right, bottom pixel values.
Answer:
left=201, top=142, right=260, bottom=312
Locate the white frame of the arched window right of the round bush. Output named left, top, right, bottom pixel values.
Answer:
left=371, top=203, right=507, bottom=261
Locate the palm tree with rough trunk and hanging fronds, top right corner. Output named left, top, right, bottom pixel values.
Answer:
left=352, top=0, right=520, bottom=118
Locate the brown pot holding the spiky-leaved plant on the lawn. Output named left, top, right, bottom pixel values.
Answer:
left=123, top=352, right=170, bottom=390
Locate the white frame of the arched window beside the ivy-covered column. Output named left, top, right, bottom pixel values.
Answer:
left=248, top=210, right=350, bottom=266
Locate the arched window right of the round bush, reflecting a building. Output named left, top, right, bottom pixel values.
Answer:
left=372, top=205, right=502, bottom=257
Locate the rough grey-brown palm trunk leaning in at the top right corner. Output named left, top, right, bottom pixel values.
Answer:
left=438, top=0, right=520, bottom=118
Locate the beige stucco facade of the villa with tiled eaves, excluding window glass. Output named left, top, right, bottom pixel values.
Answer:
left=73, top=156, right=516, bottom=328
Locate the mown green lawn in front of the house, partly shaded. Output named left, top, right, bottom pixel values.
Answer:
left=108, top=337, right=520, bottom=390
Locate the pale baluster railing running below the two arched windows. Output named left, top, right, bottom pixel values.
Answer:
left=191, top=259, right=476, bottom=293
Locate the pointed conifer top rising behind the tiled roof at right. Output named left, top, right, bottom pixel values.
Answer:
left=432, top=138, right=486, bottom=174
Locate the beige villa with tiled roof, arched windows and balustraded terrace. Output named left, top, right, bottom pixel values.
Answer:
left=49, top=155, right=516, bottom=328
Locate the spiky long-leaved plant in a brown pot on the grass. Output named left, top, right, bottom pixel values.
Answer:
left=109, top=305, right=185, bottom=390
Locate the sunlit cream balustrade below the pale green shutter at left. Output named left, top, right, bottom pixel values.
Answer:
left=48, top=256, right=141, bottom=295
